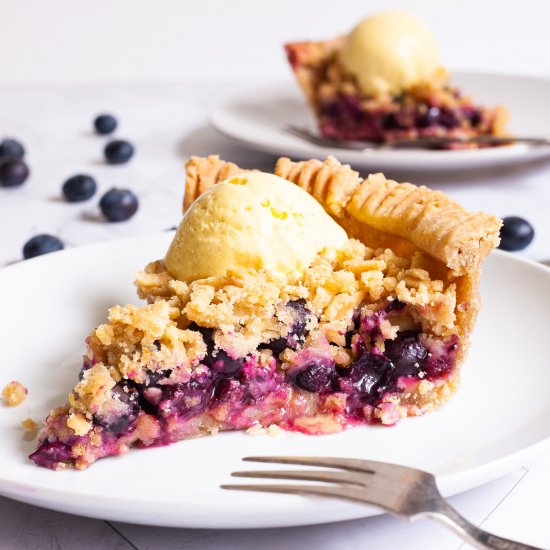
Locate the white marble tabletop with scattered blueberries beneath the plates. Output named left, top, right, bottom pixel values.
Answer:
left=0, top=81, right=550, bottom=550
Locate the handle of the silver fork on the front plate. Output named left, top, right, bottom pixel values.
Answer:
left=427, top=504, right=541, bottom=550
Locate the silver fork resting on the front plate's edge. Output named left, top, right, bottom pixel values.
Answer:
left=222, top=456, right=540, bottom=550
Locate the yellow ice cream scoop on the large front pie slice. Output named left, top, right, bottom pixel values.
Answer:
left=165, top=172, right=347, bottom=282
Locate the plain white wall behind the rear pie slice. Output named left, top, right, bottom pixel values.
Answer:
left=0, top=0, right=550, bottom=82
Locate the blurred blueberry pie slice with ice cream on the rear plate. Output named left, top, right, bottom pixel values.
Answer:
left=285, top=11, right=508, bottom=147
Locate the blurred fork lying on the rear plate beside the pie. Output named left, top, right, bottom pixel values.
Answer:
left=284, top=124, right=550, bottom=151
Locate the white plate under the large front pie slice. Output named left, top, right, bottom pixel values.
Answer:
left=0, top=233, right=550, bottom=528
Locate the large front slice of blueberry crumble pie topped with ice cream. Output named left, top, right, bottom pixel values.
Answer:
left=31, top=156, right=500, bottom=469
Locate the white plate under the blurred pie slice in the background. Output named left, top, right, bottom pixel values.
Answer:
left=211, top=73, right=550, bottom=171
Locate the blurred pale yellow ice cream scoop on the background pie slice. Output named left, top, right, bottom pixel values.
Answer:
left=341, top=11, right=439, bottom=95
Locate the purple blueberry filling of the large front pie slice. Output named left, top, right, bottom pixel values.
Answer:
left=31, top=300, right=458, bottom=468
